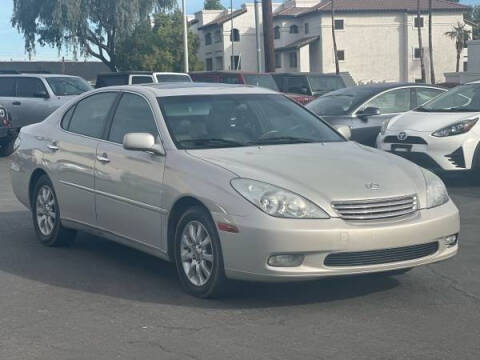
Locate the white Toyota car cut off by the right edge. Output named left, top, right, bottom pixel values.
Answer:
left=377, top=81, right=480, bottom=171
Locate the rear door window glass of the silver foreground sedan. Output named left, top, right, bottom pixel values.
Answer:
left=68, top=92, right=118, bottom=138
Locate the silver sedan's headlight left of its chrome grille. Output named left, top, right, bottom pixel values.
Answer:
left=231, top=179, right=329, bottom=219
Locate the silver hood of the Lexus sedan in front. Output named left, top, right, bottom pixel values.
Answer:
left=188, top=142, right=425, bottom=210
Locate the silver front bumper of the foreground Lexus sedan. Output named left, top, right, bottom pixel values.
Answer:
left=214, top=201, right=460, bottom=281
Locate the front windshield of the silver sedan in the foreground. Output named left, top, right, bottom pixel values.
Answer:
left=158, top=94, right=344, bottom=149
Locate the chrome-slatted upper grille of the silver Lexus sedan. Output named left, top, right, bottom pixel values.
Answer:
left=332, top=195, right=418, bottom=220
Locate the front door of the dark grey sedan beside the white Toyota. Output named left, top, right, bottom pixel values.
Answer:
left=352, top=87, right=412, bottom=146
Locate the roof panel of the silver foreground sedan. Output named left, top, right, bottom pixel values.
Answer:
left=99, top=82, right=278, bottom=97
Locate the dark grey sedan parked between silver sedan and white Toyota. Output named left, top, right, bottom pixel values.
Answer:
left=307, top=83, right=446, bottom=146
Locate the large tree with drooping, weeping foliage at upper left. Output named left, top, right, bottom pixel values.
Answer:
left=12, top=0, right=176, bottom=71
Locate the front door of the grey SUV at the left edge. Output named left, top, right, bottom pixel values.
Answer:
left=13, top=77, right=58, bottom=127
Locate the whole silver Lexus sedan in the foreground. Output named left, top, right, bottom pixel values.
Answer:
left=11, top=83, right=459, bottom=297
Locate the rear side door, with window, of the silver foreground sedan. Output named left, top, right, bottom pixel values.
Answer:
left=50, top=92, right=119, bottom=226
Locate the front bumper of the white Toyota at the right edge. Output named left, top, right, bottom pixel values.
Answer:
left=377, top=131, right=480, bottom=171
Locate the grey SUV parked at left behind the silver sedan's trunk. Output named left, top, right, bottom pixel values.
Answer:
left=0, top=74, right=92, bottom=156
